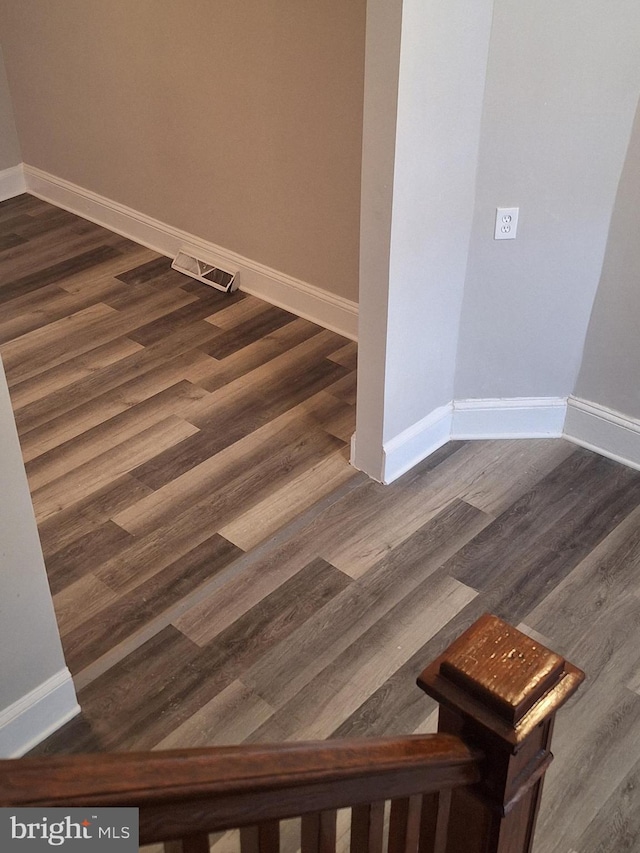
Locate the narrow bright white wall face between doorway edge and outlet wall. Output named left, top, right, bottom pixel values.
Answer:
left=384, top=0, right=493, bottom=441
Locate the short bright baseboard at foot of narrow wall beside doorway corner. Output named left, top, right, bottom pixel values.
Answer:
left=382, top=403, right=453, bottom=483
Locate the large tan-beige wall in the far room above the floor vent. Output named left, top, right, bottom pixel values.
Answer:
left=0, top=0, right=366, bottom=299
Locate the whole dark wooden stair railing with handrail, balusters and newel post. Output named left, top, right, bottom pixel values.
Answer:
left=0, top=615, right=584, bottom=853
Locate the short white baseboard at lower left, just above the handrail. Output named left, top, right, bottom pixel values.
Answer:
left=0, top=667, right=80, bottom=758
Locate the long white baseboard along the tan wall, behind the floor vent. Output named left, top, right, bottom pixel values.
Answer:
left=23, top=164, right=358, bottom=340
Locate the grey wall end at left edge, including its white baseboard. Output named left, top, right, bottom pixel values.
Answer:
left=0, top=362, right=79, bottom=758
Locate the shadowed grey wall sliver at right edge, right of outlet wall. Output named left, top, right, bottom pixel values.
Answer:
left=575, top=98, right=640, bottom=418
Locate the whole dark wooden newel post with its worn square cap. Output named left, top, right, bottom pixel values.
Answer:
left=418, top=615, right=584, bottom=853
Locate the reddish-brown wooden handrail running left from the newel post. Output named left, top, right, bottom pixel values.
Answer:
left=0, top=735, right=482, bottom=844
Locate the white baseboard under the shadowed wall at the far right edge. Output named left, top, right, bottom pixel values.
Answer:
left=564, top=397, right=640, bottom=470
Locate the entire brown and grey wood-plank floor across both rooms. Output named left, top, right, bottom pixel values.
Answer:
left=0, top=196, right=640, bottom=853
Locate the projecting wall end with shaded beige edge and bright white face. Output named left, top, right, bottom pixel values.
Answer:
left=354, top=0, right=492, bottom=480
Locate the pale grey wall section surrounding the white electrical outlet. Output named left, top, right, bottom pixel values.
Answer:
left=452, top=0, right=640, bottom=399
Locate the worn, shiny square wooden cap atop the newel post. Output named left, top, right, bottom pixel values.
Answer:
left=418, top=614, right=584, bottom=747
